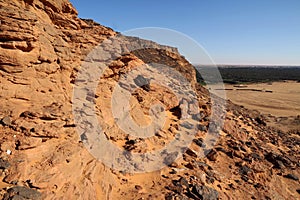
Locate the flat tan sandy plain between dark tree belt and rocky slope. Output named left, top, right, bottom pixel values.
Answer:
left=214, top=81, right=300, bottom=117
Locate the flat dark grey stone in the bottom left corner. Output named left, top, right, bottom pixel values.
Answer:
left=3, top=186, right=41, bottom=200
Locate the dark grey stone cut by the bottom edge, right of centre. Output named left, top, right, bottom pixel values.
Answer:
left=192, top=185, right=219, bottom=200
